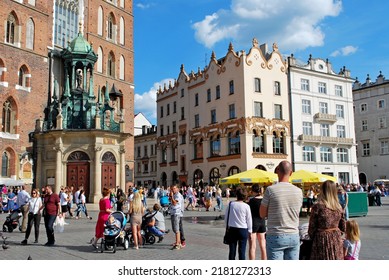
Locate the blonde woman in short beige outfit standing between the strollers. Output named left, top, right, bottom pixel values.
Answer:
left=128, top=191, right=145, bottom=250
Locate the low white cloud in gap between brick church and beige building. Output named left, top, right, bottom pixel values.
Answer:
left=134, top=79, right=174, bottom=123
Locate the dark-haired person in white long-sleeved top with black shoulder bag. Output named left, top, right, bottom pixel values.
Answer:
left=225, top=188, right=253, bottom=260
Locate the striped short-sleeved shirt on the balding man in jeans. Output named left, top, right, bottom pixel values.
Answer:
left=261, top=182, right=303, bottom=235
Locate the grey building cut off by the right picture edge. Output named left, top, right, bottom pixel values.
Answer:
left=353, top=73, right=389, bottom=184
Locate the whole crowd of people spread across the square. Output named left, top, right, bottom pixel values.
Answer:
left=0, top=161, right=372, bottom=260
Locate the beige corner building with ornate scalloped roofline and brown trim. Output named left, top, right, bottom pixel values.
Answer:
left=157, top=39, right=291, bottom=185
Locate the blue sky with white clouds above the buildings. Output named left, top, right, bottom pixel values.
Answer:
left=134, top=0, right=389, bottom=124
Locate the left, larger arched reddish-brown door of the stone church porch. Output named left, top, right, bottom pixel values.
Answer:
left=66, top=151, right=90, bottom=202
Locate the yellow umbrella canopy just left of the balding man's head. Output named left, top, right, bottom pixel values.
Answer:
left=220, top=168, right=278, bottom=184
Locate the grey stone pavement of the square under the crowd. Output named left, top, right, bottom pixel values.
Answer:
left=0, top=197, right=389, bottom=260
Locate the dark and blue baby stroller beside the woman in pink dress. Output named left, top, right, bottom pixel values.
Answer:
left=100, top=211, right=130, bottom=253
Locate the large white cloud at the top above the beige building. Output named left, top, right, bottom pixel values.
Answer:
left=192, top=0, right=342, bottom=51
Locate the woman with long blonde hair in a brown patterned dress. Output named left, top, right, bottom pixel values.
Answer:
left=308, top=180, right=346, bottom=260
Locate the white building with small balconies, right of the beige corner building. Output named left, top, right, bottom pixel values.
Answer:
left=288, top=55, right=359, bottom=183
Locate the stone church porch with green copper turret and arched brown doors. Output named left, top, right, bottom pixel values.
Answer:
left=34, top=31, right=131, bottom=202
